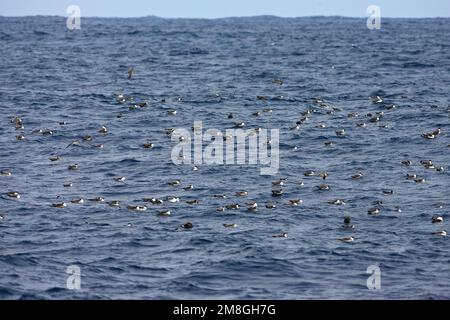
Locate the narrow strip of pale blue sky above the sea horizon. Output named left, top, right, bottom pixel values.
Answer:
left=0, top=0, right=450, bottom=18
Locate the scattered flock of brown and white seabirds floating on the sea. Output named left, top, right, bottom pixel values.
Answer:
left=0, top=75, right=447, bottom=242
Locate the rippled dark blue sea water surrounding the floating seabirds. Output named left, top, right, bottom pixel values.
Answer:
left=0, top=16, right=450, bottom=299
